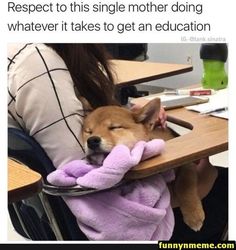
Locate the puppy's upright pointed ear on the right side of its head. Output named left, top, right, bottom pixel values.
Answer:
left=134, top=98, right=161, bottom=130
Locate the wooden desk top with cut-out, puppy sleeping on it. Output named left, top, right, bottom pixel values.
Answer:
left=126, top=108, right=228, bottom=179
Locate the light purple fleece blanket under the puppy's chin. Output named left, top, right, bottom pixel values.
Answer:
left=47, top=139, right=175, bottom=241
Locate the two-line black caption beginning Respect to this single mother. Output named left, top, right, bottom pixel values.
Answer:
left=7, top=1, right=212, bottom=34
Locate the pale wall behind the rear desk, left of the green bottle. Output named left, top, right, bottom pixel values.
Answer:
left=147, top=43, right=203, bottom=88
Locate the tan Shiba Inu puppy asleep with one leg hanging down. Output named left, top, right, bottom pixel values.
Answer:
left=83, top=98, right=205, bottom=231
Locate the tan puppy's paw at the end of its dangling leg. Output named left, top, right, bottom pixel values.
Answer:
left=184, top=208, right=205, bottom=232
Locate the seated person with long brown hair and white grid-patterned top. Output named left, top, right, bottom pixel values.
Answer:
left=8, top=44, right=228, bottom=240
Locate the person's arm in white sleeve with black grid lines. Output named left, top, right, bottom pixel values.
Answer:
left=11, top=45, right=84, bottom=167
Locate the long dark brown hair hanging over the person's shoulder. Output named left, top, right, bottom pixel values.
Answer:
left=46, top=43, right=116, bottom=108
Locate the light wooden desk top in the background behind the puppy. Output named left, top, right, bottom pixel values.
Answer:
left=111, top=60, right=193, bottom=87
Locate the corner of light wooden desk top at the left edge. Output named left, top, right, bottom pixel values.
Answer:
left=8, top=159, right=42, bottom=203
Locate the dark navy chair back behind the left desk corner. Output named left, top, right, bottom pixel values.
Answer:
left=8, top=128, right=87, bottom=240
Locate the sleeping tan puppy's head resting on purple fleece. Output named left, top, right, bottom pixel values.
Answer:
left=83, top=98, right=160, bottom=165
